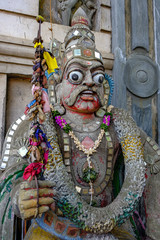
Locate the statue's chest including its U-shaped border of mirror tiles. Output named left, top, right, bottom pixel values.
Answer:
left=58, top=128, right=114, bottom=205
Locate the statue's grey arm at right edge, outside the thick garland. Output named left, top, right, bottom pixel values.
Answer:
left=141, top=130, right=160, bottom=240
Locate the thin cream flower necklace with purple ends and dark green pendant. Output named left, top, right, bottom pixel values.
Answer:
left=52, top=110, right=112, bottom=204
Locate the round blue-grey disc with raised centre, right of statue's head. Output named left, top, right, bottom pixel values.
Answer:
left=124, top=54, right=158, bottom=97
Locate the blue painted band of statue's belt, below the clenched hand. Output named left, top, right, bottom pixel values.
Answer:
left=36, top=214, right=83, bottom=240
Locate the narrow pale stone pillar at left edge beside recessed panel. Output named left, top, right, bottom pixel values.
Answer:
left=0, top=73, right=7, bottom=155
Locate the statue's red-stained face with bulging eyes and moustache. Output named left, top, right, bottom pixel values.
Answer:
left=61, top=59, right=104, bottom=113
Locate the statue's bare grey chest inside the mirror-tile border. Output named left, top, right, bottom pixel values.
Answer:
left=70, top=134, right=108, bottom=189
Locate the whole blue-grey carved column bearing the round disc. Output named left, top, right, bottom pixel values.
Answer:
left=112, top=0, right=159, bottom=140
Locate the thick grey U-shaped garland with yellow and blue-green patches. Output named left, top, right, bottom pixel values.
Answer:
left=45, top=108, right=145, bottom=233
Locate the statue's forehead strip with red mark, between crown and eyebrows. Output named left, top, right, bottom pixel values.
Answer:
left=65, top=58, right=104, bottom=71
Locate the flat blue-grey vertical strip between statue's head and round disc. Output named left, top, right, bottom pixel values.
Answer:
left=111, top=0, right=126, bottom=109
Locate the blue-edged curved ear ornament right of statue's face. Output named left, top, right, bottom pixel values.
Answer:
left=96, top=73, right=114, bottom=117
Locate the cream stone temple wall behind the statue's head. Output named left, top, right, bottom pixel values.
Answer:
left=0, top=0, right=113, bottom=161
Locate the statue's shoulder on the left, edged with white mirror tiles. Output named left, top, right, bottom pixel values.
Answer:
left=0, top=115, right=30, bottom=170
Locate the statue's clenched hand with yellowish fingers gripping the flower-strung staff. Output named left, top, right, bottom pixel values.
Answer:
left=18, top=180, right=56, bottom=219
